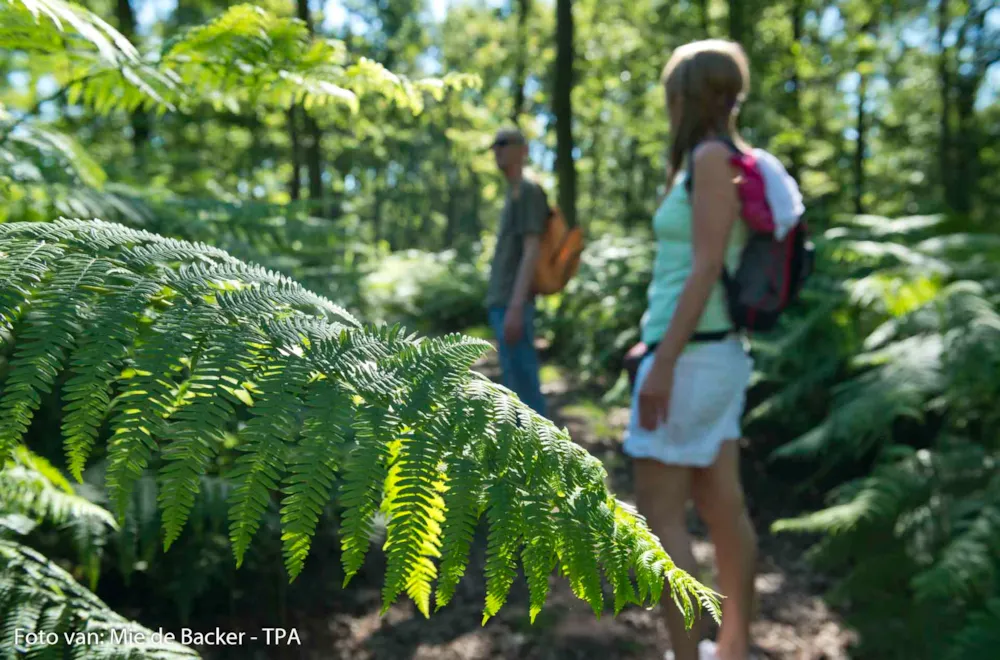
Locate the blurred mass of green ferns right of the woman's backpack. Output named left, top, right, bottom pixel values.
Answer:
left=751, top=217, right=1000, bottom=658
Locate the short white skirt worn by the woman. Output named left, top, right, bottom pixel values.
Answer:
left=623, top=336, right=753, bottom=467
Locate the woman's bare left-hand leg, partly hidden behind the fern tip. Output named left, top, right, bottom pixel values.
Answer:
left=634, top=459, right=700, bottom=660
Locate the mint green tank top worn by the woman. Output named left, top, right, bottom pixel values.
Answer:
left=642, top=172, right=746, bottom=344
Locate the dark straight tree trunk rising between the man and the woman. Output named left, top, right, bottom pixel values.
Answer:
left=552, top=0, right=576, bottom=227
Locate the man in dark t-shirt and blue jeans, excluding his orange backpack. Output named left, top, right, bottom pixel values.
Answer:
left=486, top=129, right=549, bottom=415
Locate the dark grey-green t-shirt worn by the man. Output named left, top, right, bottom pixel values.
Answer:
left=486, top=179, right=549, bottom=307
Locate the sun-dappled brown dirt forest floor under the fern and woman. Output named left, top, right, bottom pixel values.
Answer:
left=297, top=340, right=852, bottom=660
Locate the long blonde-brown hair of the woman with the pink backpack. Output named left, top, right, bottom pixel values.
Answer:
left=661, top=39, right=750, bottom=182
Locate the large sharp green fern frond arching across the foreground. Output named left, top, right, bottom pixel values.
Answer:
left=0, top=219, right=717, bottom=619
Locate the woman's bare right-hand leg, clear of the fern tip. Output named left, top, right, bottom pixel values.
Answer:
left=691, top=441, right=757, bottom=660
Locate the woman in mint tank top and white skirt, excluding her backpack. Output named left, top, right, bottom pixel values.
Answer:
left=624, top=40, right=756, bottom=660
